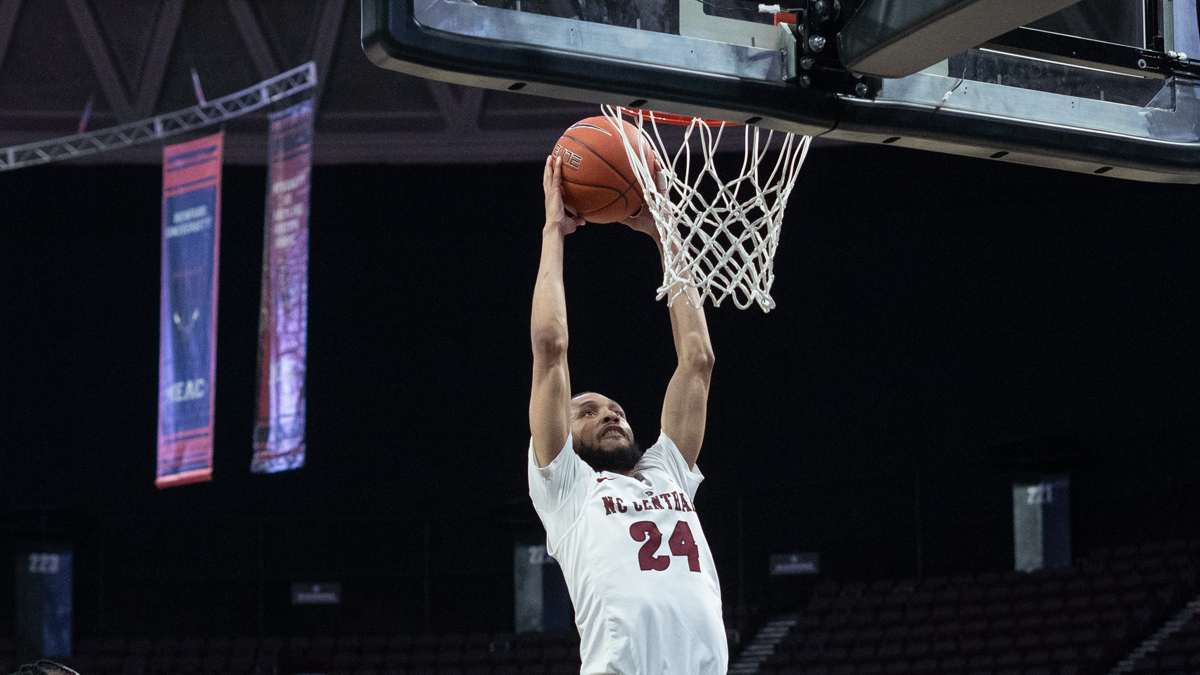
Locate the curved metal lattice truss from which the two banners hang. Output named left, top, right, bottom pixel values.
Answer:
left=0, top=61, right=317, bottom=171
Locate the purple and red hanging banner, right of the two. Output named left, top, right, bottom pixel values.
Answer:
left=250, top=101, right=312, bottom=473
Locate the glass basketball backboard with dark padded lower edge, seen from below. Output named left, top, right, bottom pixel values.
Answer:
left=362, top=0, right=1200, bottom=183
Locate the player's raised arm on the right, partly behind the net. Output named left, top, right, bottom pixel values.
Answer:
left=626, top=208, right=714, bottom=467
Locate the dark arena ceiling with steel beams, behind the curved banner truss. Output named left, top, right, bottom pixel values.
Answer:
left=0, top=0, right=596, bottom=163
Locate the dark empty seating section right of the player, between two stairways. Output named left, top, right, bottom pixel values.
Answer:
left=760, top=540, right=1200, bottom=675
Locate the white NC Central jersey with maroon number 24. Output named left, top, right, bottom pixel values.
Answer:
left=529, top=434, right=728, bottom=675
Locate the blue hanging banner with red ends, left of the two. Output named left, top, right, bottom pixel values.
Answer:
left=155, top=133, right=223, bottom=488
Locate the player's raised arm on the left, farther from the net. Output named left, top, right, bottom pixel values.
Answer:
left=529, top=157, right=583, bottom=466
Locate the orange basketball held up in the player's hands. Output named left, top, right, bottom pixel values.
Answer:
left=554, top=117, right=654, bottom=222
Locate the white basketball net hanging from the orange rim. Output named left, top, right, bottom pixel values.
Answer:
left=602, top=106, right=811, bottom=312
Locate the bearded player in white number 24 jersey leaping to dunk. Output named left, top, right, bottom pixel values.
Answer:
left=529, top=157, right=728, bottom=675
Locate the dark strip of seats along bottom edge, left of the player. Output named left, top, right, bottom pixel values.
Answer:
left=51, top=633, right=580, bottom=675
